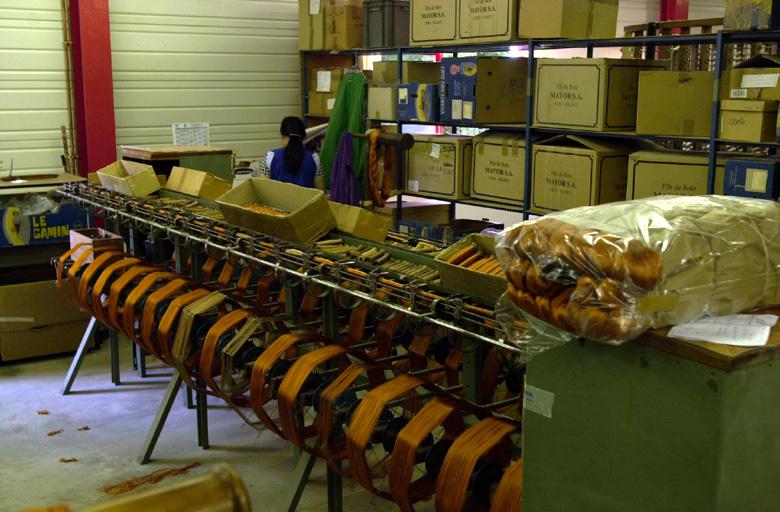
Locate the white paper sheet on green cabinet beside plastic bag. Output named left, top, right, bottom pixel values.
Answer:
left=669, top=315, right=777, bottom=347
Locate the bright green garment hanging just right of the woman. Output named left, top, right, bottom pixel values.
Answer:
left=321, top=72, right=368, bottom=188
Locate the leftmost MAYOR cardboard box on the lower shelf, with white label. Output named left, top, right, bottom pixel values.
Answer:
left=404, top=134, right=473, bottom=199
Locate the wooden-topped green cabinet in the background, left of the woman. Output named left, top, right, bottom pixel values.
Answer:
left=121, top=145, right=233, bottom=182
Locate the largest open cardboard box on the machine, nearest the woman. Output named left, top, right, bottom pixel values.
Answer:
left=217, top=178, right=336, bottom=244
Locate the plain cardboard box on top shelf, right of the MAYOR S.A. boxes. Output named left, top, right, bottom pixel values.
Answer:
left=518, top=0, right=622, bottom=39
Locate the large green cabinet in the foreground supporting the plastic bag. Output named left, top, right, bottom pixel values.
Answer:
left=523, top=309, right=780, bottom=512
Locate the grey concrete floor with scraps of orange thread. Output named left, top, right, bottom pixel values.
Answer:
left=0, top=342, right=433, bottom=512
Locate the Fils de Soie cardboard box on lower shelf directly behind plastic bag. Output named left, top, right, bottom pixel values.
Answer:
left=626, top=151, right=725, bottom=199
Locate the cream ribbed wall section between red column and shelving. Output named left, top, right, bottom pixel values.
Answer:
left=109, top=0, right=300, bottom=163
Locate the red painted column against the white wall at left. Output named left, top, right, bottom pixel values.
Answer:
left=69, top=0, right=116, bottom=176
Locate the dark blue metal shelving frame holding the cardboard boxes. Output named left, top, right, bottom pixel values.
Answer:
left=301, top=31, right=780, bottom=221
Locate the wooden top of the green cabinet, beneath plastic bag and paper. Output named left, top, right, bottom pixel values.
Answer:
left=636, top=308, right=780, bottom=371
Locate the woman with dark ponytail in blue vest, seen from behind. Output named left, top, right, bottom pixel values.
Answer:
left=258, top=117, right=325, bottom=190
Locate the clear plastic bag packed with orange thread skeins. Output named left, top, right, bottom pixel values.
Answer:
left=497, top=196, right=780, bottom=344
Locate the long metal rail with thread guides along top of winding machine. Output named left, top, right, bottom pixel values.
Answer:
left=57, top=184, right=519, bottom=352
